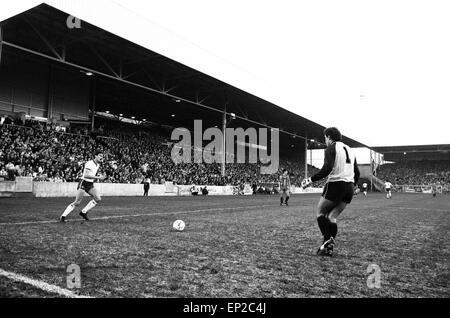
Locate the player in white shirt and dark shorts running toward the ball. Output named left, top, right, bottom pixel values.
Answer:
left=59, top=151, right=105, bottom=222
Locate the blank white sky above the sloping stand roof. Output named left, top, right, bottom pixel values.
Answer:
left=0, top=0, right=450, bottom=146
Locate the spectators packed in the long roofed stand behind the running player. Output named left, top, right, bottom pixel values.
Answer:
left=0, top=116, right=324, bottom=186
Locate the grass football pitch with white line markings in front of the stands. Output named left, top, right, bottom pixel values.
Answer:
left=0, top=193, right=450, bottom=298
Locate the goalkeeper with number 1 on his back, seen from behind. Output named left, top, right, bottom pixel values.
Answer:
left=302, top=127, right=360, bottom=256
